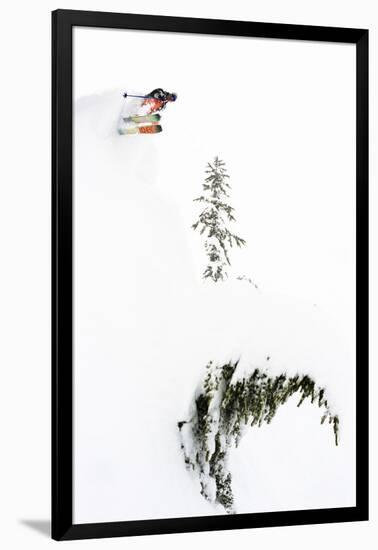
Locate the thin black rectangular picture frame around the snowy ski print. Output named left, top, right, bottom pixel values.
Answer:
left=52, top=10, right=368, bottom=540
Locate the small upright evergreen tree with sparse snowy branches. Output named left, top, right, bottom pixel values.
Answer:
left=192, top=157, right=246, bottom=282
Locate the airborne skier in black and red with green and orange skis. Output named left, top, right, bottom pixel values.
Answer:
left=118, top=88, right=177, bottom=135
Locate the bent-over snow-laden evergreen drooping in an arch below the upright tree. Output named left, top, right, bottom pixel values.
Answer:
left=177, top=361, right=339, bottom=513
